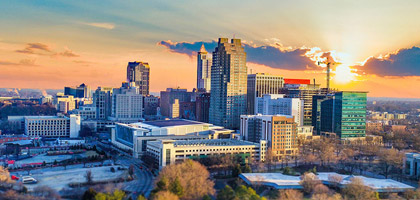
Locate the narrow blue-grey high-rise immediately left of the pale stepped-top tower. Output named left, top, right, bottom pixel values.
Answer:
left=93, top=87, right=113, bottom=120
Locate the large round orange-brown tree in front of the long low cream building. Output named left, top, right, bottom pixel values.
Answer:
left=157, top=160, right=214, bottom=199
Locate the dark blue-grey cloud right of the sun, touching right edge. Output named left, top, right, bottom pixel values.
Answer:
left=354, top=46, right=420, bottom=76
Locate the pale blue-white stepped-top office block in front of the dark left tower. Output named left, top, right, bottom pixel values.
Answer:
left=112, top=83, right=143, bottom=123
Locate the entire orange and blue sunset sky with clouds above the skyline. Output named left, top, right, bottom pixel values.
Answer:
left=0, top=0, right=420, bottom=98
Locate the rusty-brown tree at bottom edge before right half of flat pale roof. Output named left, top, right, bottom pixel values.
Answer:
left=342, top=178, right=376, bottom=200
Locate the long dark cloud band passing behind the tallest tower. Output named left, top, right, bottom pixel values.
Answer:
left=158, top=40, right=331, bottom=70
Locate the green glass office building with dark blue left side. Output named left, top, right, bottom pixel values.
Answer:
left=320, top=91, right=367, bottom=139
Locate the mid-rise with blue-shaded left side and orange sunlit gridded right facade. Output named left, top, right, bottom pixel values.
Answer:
left=240, top=115, right=298, bottom=160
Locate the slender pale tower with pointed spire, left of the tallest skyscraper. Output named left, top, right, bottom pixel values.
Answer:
left=197, top=44, right=211, bottom=92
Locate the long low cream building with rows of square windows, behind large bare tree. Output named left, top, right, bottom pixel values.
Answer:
left=147, top=139, right=267, bottom=169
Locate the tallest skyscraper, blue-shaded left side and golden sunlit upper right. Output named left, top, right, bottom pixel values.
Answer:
left=209, top=38, right=247, bottom=129
